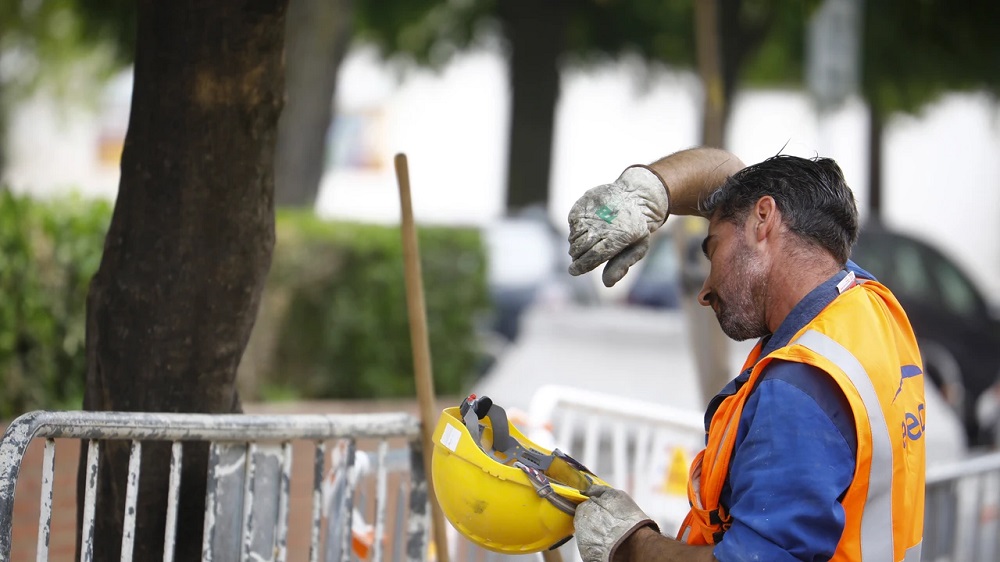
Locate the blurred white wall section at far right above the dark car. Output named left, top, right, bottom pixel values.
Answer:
left=883, top=91, right=1000, bottom=303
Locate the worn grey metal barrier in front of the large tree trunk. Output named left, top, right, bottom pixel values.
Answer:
left=0, top=411, right=430, bottom=562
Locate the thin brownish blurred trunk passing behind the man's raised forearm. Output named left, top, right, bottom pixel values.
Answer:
left=674, top=0, right=733, bottom=405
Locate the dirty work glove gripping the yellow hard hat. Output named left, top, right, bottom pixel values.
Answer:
left=573, top=485, right=660, bottom=562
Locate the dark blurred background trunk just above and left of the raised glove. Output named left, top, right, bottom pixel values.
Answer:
left=499, top=0, right=569, bottom=213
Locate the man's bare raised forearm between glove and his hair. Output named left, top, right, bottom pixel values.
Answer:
left=648, top=147, right=745, bottom=215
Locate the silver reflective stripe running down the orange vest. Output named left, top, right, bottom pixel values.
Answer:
left=792, top=330, right=920, bottom=562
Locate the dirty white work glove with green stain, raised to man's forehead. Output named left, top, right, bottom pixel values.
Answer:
left=569, top=162, right=670, bottom=287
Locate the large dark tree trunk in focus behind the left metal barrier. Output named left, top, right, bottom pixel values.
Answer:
left=78, top=0, right=287, bottom=560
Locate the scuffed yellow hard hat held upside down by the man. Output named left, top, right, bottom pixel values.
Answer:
left=431, top=394, right=607, bottom=554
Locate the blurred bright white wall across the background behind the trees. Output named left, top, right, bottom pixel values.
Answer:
left=5, top=46, right=1000, bottom=302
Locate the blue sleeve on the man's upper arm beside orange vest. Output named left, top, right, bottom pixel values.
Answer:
left=714, top=362, right=857, bottom=562
